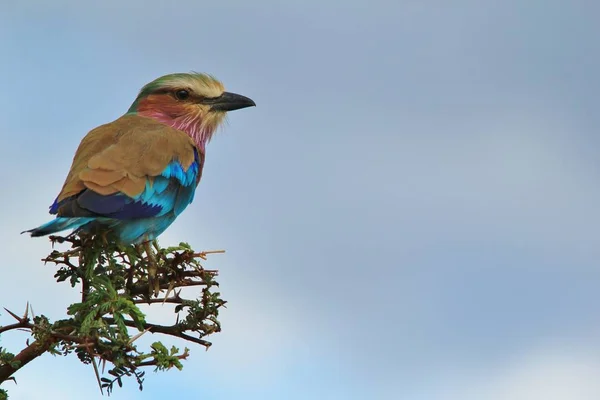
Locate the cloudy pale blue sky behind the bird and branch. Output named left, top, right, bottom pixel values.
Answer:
left=0, top=0, right=600, bottom=400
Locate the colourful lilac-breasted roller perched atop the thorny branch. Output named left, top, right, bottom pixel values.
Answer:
left=27, top=73, right=256, bottom=244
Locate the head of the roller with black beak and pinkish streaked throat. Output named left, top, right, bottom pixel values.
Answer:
left=128, top=73, right=256, bottom=148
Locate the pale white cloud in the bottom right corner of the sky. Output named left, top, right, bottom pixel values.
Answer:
left=375, top=341, right=600, bottom=400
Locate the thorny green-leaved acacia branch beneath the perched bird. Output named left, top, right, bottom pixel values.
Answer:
left=0, top=234, right=225, bottom=397
